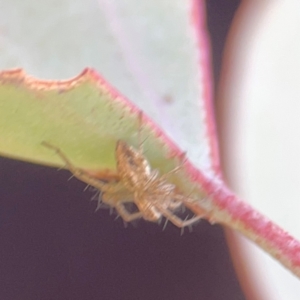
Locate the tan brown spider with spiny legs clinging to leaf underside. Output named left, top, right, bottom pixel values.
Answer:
left=42, top=114, right=201, bottom=228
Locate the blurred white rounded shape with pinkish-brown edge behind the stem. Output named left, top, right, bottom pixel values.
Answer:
left=217, top=0, right=300, bottom=300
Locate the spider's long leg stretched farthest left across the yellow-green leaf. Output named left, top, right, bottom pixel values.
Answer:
left=42, top=142, right=120, bottom=193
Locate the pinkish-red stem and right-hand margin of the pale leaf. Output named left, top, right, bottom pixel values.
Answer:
left=187, top=0, right=300, bottom=278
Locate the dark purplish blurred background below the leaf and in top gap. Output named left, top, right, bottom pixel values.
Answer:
left=0, top=0, right=245, bottom=300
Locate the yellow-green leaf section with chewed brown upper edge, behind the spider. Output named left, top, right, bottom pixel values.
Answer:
left=0, top=69, right=184, bottom=180
